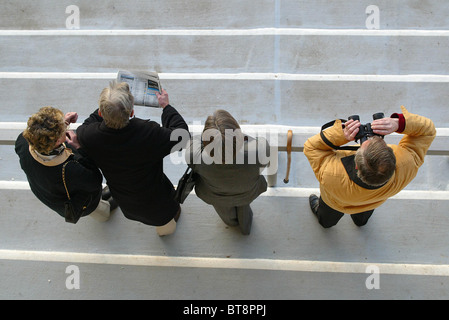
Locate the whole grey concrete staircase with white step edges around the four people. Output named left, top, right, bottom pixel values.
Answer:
left=0, top=0, right=449, bottom=300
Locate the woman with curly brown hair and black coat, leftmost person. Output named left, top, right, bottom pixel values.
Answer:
left=15, top=107, right=116, bottom=223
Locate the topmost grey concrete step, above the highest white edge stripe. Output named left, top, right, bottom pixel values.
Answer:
left=0, top=0, right=449, bottom=29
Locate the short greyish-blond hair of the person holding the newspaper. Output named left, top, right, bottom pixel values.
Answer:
left=99, top=81, right=134, bottom=129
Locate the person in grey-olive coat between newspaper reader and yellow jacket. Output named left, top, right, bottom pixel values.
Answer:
left=186, top=110, right=269, bottom=235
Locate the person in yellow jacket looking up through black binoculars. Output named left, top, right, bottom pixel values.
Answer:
left=304, top=106, right=436, bottom=228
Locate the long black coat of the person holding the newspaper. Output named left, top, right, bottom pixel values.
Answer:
left=77, top=105, right=188, bottom=226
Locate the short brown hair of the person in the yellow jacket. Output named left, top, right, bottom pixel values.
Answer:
left=355, top=136, right=396, bottom=187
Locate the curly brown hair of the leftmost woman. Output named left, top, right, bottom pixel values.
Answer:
left=23, top=106, right=67, bottom=154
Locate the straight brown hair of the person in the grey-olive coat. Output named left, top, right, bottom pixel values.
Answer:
left=203, top=110, right=244, bottom=163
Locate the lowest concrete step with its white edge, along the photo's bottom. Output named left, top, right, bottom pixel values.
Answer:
left=0, top=252, right=449, bottom=300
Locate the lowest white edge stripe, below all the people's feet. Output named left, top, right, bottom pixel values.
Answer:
left=0, top=250, right=449, bottom=276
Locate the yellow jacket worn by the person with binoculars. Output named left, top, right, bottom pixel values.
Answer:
left=304, top=106, right=436, bottom=214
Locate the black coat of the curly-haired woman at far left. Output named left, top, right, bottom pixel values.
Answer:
left=15, top=134, right=103, bottom=217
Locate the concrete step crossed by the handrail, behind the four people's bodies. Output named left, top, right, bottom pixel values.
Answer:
left=0, top=122, right=449, bottom=191
